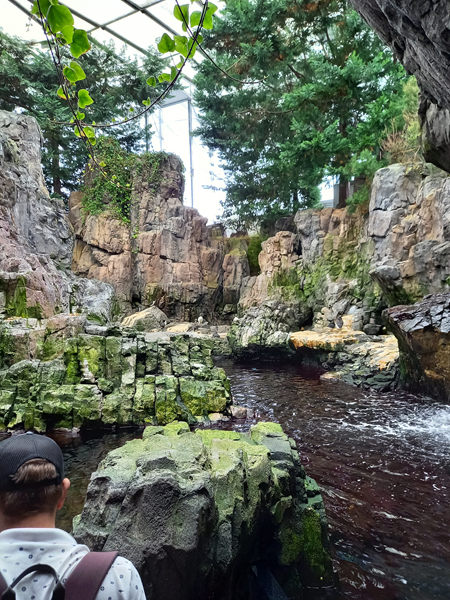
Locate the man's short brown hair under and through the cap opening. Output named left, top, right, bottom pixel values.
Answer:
left=0, top=458, right=62, bottom=520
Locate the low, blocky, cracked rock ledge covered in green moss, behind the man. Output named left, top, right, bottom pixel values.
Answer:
left=0, top=315, right=231, bottom=431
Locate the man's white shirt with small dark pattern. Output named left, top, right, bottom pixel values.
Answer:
left=0, top=528, right=145, bottom=600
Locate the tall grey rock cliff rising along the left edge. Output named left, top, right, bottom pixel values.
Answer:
left=0, top=111, right=114, bottom=321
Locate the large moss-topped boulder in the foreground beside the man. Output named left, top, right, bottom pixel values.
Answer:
left=74, top=423, right=333, bottom=600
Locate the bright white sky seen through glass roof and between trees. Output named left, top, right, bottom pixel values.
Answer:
left=0, top=0, right=225, bottom=220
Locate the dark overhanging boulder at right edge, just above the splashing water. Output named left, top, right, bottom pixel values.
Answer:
left=386, top=293, right=450, bottom=402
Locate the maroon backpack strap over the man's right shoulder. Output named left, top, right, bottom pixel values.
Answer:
left=64, top=552, right=118, bottom=600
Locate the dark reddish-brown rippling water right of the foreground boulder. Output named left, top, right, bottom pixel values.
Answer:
left=222, top=363, right=450, bottom=600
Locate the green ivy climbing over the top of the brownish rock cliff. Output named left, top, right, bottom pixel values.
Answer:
left=82, top=137, right=167, bottom=226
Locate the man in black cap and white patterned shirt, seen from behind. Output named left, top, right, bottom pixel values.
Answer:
left=0, top=433, right=145, bottom=600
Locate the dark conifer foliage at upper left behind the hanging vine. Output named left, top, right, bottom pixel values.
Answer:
left=0, top=30, right=165, bottom=197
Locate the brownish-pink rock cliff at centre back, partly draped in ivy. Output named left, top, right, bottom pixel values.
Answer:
left=69, top=155, right=249, bottom=321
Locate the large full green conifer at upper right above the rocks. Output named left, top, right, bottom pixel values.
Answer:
left=195, top=0, right=406, bottom=228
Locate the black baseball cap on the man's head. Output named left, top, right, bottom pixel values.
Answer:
left=0, top=432, right=64, bottom=492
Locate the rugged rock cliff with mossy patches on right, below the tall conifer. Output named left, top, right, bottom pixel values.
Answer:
left=230, top=165, right=450, bottom=364
